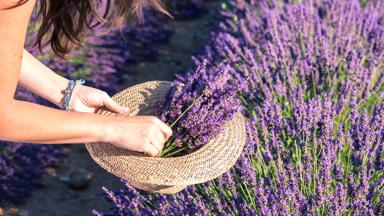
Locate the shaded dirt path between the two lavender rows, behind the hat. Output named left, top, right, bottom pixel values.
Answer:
left=0, top=3, right=218, bottom=216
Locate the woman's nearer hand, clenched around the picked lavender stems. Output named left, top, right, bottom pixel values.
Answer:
left=103, top=115, right=172, bottom=156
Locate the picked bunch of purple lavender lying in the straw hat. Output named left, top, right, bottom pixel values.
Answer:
left=158, top=62, right=241, bottom=153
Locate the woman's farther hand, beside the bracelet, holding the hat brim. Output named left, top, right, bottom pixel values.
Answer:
left=69, top=84, right=129, bottom=113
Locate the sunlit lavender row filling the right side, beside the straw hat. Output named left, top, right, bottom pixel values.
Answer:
left=98, top=0, right=384, bottom=215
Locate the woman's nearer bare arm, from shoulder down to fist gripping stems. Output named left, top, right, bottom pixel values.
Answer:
left=0, top=0, right=172, bottom=156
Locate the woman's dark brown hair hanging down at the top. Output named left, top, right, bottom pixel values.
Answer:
left=8, top=0, right=171, bottom=57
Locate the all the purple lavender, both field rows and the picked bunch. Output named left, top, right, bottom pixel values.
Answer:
left=0, top=0, right=384, bottom=215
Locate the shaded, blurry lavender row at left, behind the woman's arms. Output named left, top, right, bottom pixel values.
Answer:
left=0, top=0, right=208, bottom=206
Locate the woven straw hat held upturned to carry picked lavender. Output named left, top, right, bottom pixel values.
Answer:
left=86, top=81, right=246, bottom=194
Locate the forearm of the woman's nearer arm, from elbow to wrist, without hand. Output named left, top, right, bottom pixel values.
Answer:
left=0, top=100, right=113, bottom=144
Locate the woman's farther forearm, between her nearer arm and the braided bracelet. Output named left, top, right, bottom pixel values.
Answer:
left=18, top=50, right=68, bottom=107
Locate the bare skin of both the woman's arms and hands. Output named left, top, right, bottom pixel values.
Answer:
left=0, top=0, right=172, bottom=156
